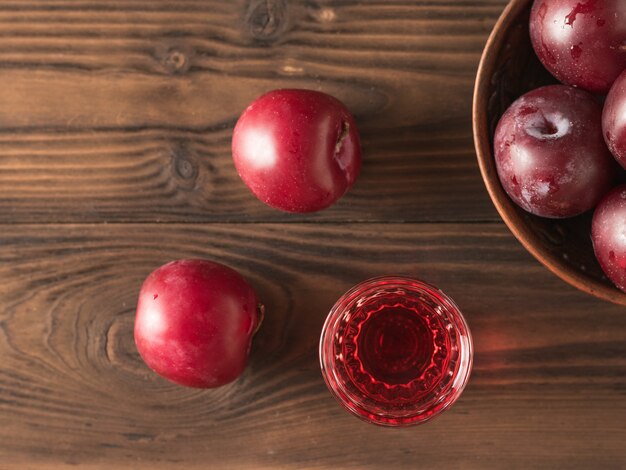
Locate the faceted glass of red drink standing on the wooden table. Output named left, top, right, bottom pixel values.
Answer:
left=320, top=276, right=473, bottom=426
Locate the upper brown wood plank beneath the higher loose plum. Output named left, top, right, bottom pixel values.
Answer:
left=0, top=0, right=505, bottom=223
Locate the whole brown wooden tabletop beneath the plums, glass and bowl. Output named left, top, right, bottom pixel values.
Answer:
left=0, top=0, right=626, bottom=469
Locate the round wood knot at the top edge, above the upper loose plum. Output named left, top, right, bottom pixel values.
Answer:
left=245, top=0, right=287, bottom=42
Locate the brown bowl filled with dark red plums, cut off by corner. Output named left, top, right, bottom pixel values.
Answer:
left=473, top=0, right=626, bottom=305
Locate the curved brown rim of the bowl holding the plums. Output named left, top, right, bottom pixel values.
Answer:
left=472, top=0, right=626, bottom=306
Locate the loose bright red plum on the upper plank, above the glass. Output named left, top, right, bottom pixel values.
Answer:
left=232, top=89, right=361, bottom=212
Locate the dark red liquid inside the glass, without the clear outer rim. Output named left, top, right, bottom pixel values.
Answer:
left=342, top=298, right=449, bottom=402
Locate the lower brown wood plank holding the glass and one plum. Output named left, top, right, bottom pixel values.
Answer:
left=0, top=224, right=626, bottom=469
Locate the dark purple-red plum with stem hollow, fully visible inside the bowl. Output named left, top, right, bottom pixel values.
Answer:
left=494, top=85, right=617, bottom=218
